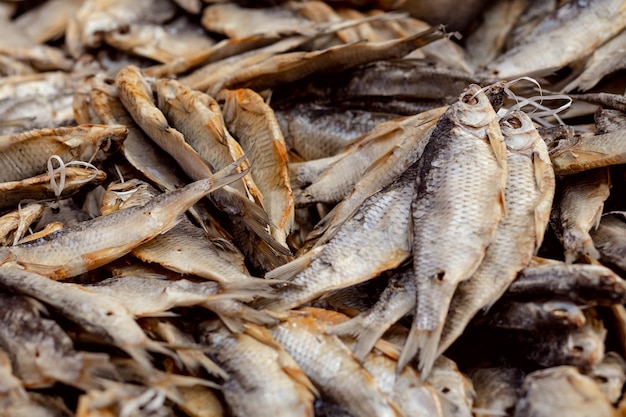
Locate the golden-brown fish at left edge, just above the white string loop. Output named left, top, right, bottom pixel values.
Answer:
left=0, top=124, right=128, bottom=182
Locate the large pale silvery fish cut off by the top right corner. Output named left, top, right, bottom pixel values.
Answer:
left=486, top=0, right=626, bottom=79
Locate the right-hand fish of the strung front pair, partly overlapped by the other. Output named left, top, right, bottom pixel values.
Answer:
left=438, top=112, right=555, bottom=354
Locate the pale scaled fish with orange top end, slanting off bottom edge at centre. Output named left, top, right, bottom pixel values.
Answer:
left=270, top=309, right=400, bottom=417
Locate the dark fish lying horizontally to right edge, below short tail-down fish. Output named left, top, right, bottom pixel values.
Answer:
left=505, top=262, right=626, bottom=305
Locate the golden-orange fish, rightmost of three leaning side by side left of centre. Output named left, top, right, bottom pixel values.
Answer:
left=217, top=89, right=294, bottom=246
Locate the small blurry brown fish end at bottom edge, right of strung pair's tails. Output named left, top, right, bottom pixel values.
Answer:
left=468, top=365, right=525, bottom=417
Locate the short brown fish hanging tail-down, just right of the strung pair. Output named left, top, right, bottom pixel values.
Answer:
left=552, top=168, right=611, bottom=263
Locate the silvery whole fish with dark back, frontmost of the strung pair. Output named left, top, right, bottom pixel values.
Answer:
left=398, top=85, right=507, bottom=378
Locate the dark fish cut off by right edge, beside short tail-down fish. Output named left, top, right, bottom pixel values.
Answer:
left=591, top=212, right=626, bottom=271
